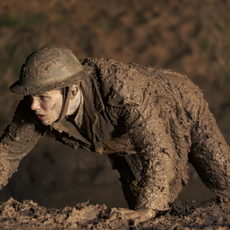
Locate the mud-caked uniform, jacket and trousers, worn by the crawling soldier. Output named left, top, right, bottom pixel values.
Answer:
left=0, top=58, right=230, bottom=210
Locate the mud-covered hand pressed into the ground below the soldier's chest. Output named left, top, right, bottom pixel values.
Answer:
left=112, top=208, right=156, bottom=222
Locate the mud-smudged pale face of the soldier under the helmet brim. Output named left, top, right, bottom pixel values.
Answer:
left=30, top=90, right=63, bottom=125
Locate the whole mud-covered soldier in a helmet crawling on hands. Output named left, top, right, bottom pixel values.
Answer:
left=0, top=46, right=230, bottom=219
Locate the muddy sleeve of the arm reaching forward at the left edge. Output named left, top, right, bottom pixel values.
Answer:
left=0, top=97, right=44, bottom=189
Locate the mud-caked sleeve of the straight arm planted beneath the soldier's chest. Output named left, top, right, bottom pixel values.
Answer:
left=124, top=106, right=176, bottom=211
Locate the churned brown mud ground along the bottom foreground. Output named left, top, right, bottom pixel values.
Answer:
left=0, top=197, right=230, bottom=230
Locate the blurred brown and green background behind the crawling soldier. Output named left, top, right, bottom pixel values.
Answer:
left=0, top=0, right=230, bottom=208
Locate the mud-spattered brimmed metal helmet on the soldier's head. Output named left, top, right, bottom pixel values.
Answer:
left=10, top=46, right=92, bottom=96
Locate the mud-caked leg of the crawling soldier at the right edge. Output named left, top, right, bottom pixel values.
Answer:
left=189, top=98, right=230, bottom=198
